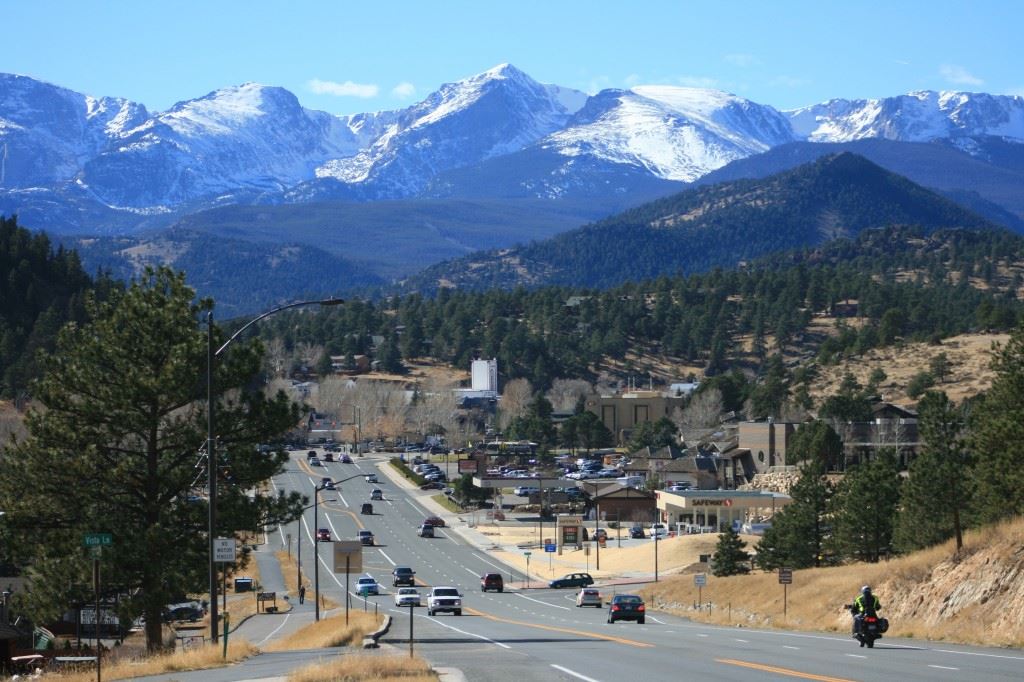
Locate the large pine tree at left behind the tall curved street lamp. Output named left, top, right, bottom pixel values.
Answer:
left=0, top=268, right=303, bottom=649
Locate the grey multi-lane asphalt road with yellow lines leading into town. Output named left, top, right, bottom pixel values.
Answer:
left=142, top=452, right=1024, bottom=682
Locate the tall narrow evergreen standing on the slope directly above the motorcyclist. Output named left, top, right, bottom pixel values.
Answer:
left=895, top=391, right=973, bottom=552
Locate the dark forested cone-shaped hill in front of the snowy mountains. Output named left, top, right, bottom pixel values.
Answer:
left=406, top=153, right=994, bottom=292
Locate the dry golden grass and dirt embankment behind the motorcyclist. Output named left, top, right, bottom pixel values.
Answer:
left=644, top=519, right=1024, bottom=647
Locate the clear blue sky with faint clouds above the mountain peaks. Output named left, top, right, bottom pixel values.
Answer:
left=9, top=0, right=1024, bottom=114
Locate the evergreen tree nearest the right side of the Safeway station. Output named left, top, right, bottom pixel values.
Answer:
left=757, top=462, right=833, bottom=570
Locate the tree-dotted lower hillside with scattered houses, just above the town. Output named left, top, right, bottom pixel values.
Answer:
left=261, top=227, right=1024, bottom=403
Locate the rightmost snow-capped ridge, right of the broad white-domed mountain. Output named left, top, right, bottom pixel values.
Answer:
left=785, top=90, right=1024, bottom=146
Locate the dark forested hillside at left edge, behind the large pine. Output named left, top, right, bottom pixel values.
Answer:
left=0, top=216, right=113, bottom=396
